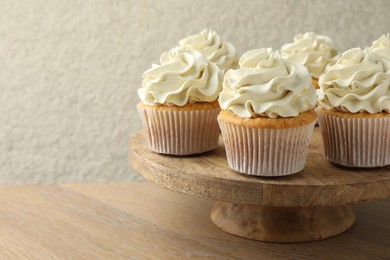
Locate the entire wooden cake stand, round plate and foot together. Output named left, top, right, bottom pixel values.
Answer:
left=129, top=128, right=390, bottom=242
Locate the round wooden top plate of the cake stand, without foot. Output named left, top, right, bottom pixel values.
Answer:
left=129, top=128, right=390, bottom=207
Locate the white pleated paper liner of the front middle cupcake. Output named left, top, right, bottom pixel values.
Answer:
left=218, top=119, right=315, bottom=177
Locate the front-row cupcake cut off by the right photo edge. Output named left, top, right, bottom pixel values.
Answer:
left=318, top=48, right=390, bottom=167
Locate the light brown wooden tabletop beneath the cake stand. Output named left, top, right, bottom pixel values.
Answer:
left=0, top=183, right=390, bottom=259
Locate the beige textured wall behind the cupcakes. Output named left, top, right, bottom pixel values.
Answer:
left=0, top=0, right=390, bottom=183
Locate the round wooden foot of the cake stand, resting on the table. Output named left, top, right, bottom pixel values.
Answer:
left=211, top=202, right=356, bottom=243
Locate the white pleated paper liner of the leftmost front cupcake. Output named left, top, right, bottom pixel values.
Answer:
left=137, top=105, right=220, bottom=155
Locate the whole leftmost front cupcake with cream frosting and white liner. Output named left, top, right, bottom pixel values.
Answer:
left=137, top=50, right=223, bottom=155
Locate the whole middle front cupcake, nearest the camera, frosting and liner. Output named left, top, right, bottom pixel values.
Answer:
left=218, top=49, right=317, bottom=176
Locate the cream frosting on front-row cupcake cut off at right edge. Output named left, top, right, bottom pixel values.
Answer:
left=318, top=48, right=390, bottom=114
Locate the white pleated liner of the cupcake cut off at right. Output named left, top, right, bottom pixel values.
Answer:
left=318, top=112, right=390, bottom=167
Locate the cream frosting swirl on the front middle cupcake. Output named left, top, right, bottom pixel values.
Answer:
left=219, top=48, right=317, bottom=118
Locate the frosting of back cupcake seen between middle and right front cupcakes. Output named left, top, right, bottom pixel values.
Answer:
left=280, top=32, right=337, bottom=79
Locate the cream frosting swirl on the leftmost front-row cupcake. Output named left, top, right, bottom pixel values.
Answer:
left=138, top=49, right=223, bottom=106
